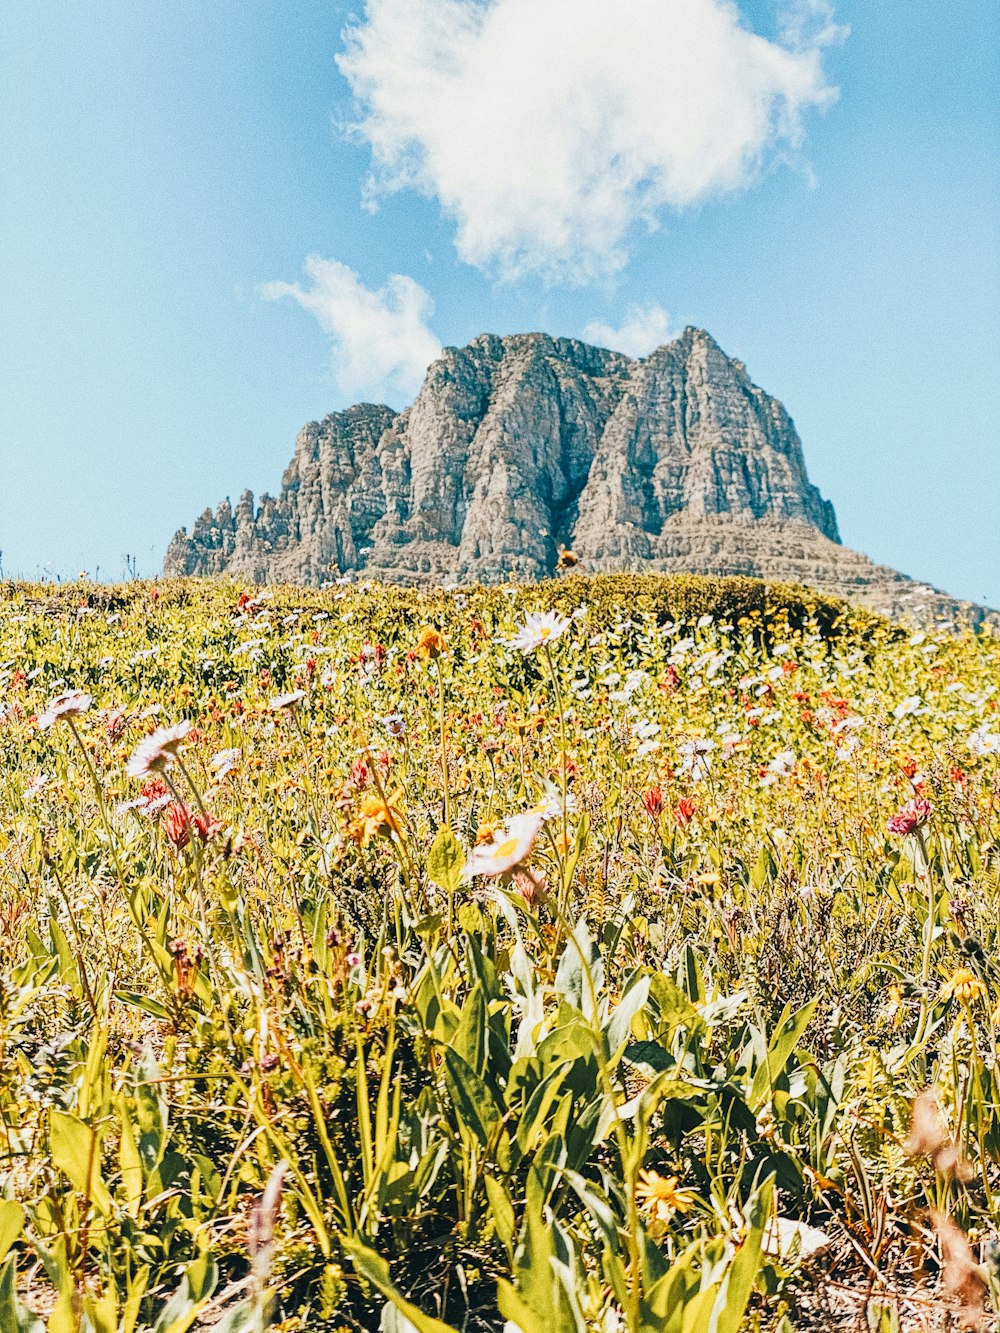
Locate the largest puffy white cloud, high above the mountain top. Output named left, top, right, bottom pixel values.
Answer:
left=339, top=0, right=843, bottom=281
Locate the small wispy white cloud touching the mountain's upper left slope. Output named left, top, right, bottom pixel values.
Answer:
left=261, top=255, right=441, bottom=403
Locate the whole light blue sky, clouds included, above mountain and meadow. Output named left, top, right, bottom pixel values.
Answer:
left=0, top=0, right=1000, bottom=607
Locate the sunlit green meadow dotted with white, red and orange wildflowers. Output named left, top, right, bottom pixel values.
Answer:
left=0, top=573, right=1000, bottom=1333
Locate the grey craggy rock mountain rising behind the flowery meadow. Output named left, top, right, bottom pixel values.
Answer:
left=164, top=328, right=989, bottom=623
